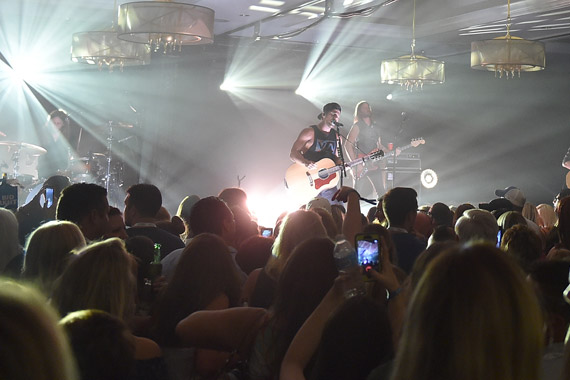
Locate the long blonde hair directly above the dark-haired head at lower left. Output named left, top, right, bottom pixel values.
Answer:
left=53, top=238, right=136, bottom=322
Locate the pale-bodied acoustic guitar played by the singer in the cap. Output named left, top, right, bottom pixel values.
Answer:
left=285, top=150, right=384, bottom=199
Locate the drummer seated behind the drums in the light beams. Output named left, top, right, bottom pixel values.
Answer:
left=38, top=110, right=75, bottom=178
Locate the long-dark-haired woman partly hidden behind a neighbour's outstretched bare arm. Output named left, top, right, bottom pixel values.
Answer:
left=153, top=233, right=240, bottom=379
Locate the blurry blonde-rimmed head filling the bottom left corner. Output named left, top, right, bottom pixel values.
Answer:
left=0, top=280, right=79, bottom=380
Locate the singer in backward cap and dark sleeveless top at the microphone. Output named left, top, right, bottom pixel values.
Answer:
left=289, top=103, right=341, bottom=201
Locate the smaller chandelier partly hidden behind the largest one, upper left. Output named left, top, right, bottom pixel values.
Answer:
left=71, top=30, right=150, bottom=72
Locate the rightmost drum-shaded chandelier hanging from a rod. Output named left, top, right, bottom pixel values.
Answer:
left=471, top=0, right=546, bottom=79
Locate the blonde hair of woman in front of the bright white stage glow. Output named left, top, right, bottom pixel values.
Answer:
left=265, top=210, right=327, bottom=280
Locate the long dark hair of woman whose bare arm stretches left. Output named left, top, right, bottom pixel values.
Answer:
left=269, top=237, right=338, bottom=373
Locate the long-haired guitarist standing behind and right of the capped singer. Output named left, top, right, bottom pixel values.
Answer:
left=345, top=101, right=400, bottom=197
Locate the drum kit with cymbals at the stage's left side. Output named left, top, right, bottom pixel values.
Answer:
left=0, top=121, right=134, bottom=205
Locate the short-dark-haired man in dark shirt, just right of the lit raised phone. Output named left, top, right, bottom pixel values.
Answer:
left=382, top=187, right=426, bottom=273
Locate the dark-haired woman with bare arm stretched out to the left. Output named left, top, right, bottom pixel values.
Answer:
left=176, top=238, right=338, bottom=380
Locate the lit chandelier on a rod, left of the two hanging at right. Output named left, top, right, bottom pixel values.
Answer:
left=380, top=0, right=445, bottom=91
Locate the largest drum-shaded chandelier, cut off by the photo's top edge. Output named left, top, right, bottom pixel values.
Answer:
left=118, top=1, right=214, bottom=53
